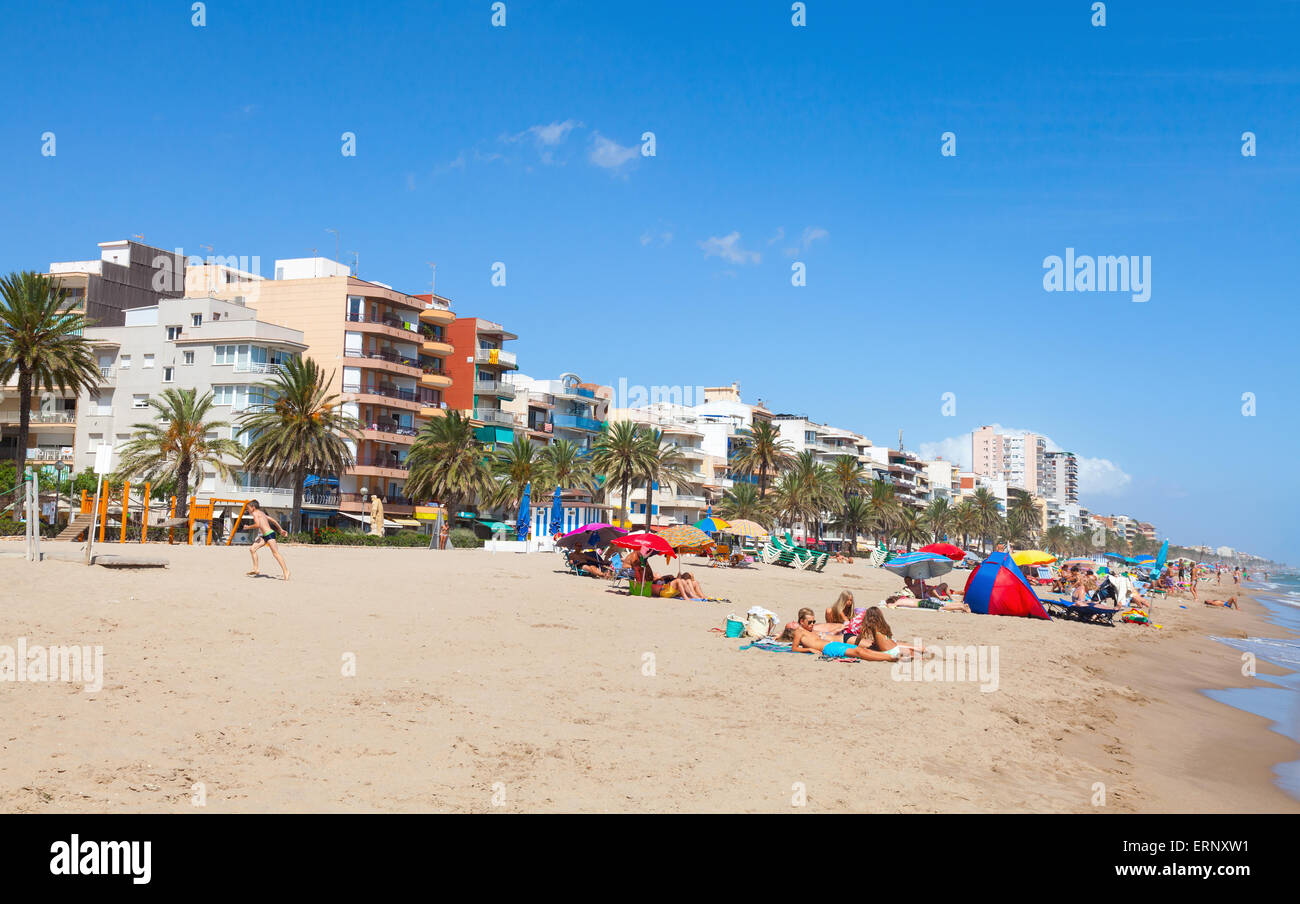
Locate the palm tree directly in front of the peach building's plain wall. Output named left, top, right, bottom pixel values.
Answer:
left=239, top=358, right=361, bottom=532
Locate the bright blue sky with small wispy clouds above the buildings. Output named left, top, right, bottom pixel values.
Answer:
left=0, top=0, right=1300, bottom=558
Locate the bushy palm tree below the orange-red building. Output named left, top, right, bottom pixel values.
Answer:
left=406, top=410, right=495, bottom=515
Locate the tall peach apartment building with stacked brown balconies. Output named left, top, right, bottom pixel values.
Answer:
left=217, top=258, right=455, bottom=525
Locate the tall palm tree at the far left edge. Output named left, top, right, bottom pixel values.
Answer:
left=0, top=271, right=99, bottom=481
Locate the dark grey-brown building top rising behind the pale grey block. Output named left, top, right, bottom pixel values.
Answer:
left=49, top=239, right=186, bottom=326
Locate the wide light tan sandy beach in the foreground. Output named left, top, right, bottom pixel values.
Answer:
left=0, top=544, right=1300, bottom=813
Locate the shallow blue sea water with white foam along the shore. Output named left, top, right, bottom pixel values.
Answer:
left=1201, top=575, right=1300, bottom=799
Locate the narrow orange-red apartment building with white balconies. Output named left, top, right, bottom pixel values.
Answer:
left=446, top=317, right=519, bottom=451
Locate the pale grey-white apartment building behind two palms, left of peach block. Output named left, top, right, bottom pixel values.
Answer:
left=72, top=298, right=306, bottom=516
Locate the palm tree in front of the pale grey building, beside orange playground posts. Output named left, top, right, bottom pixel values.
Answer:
left=113, top=389, right=243, bottom=518
